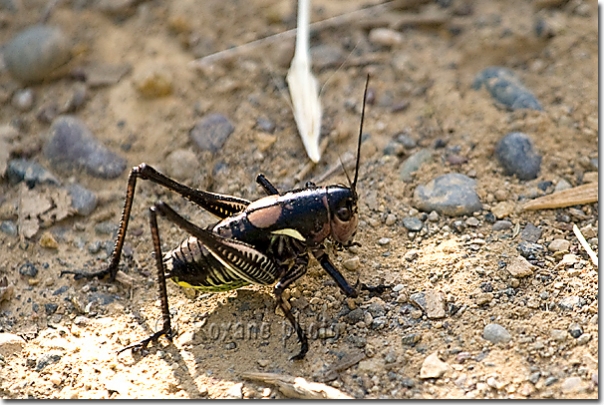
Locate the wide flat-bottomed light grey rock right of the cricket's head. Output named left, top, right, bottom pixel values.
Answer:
left=413, top=173, right=482, bottom=216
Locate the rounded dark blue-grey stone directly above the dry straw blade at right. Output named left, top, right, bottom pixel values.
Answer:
left=495, top=132, right=541, bottom=180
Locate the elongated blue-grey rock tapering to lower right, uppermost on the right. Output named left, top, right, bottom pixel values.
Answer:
left=472, top=66, right=543, bottom=111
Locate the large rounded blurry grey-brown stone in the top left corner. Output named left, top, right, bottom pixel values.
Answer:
left=3, top=25, right=71, bottom=83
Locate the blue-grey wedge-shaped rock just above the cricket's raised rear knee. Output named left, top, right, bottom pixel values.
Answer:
left=44, top=115, right=126, bottom=179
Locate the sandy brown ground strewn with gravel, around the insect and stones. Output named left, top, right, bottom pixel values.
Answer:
left=0, top=0, right=598, bottom=399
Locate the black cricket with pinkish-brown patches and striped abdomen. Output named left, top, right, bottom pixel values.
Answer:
left=61, top=77, right=383, bottom=360
